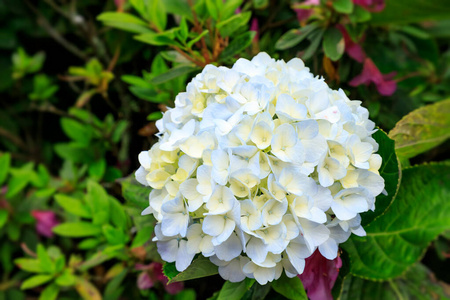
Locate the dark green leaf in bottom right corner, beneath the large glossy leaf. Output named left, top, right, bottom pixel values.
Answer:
left=338, top=263, right=448, bottom=300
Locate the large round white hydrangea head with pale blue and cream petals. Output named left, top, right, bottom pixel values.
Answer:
left=136, top=53, right=384, bottom=284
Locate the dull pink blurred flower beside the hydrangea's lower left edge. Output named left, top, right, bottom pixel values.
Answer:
left=134, top=262, right=184, bottom=295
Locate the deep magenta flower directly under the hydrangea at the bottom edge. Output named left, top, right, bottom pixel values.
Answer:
left=298, top=251, right=342, bottom=300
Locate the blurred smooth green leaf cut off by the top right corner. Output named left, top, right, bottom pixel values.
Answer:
left=371, top=0, right=450, bottom=25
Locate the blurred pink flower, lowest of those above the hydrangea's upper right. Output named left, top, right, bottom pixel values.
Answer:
left=349, top=58, right=397, bottom=96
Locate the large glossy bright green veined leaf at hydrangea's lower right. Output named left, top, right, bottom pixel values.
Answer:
left=341, top=164, right=450, bottom=280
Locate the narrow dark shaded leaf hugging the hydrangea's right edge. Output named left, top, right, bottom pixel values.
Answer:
left=361, top=129, right=401, bottom=226
